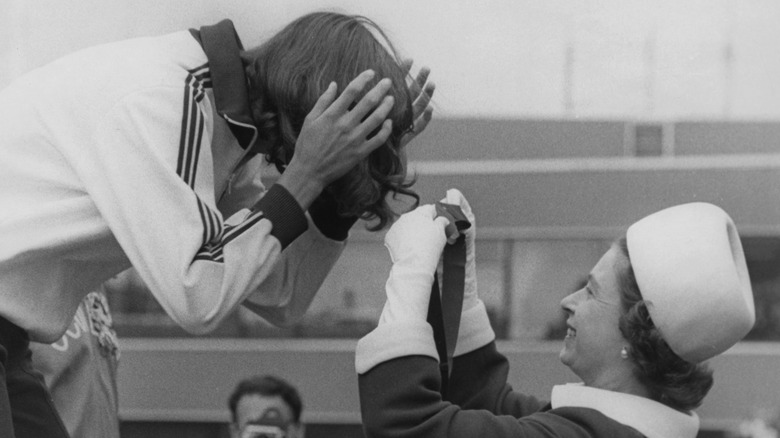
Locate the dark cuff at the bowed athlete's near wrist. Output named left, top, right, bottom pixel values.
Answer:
left=252, top=184, right=309, bottom=249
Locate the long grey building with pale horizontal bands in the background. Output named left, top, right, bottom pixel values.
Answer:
left=110, top=119, right=780, bottom=433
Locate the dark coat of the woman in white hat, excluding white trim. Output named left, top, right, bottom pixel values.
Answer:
left=359, top=342, right=695, bottom=438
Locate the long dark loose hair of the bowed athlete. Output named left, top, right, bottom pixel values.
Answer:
left=243, top=12, right=419, bottom=230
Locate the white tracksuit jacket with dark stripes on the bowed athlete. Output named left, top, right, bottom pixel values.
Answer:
left=0, top=20, right=354, bottom=342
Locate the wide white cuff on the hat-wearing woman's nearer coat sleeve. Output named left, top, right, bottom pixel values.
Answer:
left=355, top=321, right=439, bottom=374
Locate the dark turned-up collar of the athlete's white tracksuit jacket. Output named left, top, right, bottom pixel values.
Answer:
left=190, top=19, right=257, bottom=149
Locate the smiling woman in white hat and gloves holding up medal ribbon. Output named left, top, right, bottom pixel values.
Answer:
left=356, top=197, right=755, bottom=438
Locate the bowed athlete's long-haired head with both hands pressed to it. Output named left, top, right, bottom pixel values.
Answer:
left=247, top=12, right=435, bottom=231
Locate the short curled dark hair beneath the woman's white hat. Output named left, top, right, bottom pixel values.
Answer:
left=617, top=237, right=713, bottom=412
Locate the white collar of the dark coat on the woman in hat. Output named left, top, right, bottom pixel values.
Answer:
left=551, top=384, right=699, bottom=438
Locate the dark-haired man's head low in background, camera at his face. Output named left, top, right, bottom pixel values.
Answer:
left=228, top=375, right=305, bottom=438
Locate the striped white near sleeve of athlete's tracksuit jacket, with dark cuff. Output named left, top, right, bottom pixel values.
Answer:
left=68, top=87, right=307, bottom=333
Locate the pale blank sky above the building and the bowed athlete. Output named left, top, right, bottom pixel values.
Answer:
left=0, top=0, right=780, bottom=120
